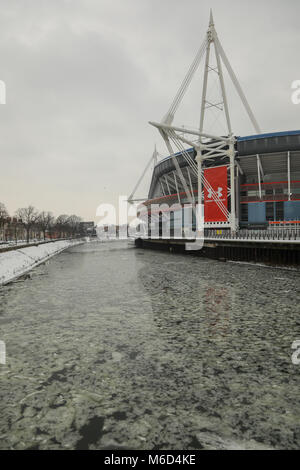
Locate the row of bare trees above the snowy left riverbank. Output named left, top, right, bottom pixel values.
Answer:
left=0, top=202, right=82, bottom=243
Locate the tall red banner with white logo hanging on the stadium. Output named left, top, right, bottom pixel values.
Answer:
left=204, top=166, right=228, bottom=222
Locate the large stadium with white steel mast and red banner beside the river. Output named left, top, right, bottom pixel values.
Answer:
left=129, top=13, right=300, bottom=236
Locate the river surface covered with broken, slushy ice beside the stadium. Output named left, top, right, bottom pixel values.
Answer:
left=0, top=241, right=300, bottom=450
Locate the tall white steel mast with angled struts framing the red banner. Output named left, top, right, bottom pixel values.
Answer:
left=150, top=11, right=261, bottom=231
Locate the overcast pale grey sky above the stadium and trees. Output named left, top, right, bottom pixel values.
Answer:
left=0, top=0, right=300, bottom=220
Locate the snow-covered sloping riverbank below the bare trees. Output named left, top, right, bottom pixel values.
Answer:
left=0, top=240, right=83, bottom=286
